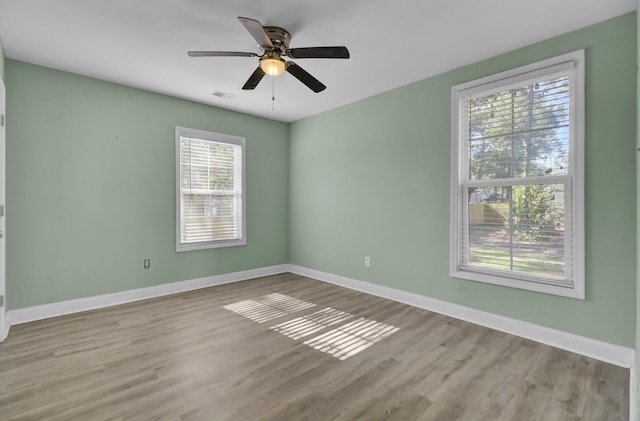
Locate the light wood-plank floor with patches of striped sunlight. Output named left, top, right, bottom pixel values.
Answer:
left=0, top=274, right=629, bottom=421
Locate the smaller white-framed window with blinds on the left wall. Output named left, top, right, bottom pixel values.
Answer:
left=176, top=127, right=246, bottom=251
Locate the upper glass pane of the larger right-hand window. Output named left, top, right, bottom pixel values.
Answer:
left=467, top=76, right=570, bottom=180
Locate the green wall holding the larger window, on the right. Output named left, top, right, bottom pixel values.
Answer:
left=289, top=13, right=636, bottom=348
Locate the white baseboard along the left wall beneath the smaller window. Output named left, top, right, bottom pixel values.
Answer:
left=7, top=265, right=289, bottom=331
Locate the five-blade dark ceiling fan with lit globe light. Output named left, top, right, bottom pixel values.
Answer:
left=187, top=17, right=349, bottom=93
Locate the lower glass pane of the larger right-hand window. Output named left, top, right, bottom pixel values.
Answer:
left=463, top=184, right=571, bottom=277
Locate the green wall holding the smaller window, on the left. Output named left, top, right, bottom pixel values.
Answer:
left=6, top=59, right=289, bottom=309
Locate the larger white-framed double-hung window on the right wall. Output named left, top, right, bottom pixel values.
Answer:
left=450, top=50, right=584, bottom=299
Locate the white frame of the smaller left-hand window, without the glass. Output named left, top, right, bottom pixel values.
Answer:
left=175, top=126, right=247, bottom=252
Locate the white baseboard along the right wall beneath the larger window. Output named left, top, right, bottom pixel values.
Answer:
left=289, top=265, right=635, bottom=370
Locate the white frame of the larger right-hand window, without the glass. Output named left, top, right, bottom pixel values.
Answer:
left=449, top=50, right=585, bottom=299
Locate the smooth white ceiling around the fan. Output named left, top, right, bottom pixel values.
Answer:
left=0, top=0, right=636, bottom=122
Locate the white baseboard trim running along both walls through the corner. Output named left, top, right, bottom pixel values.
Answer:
left=7, top=264, right=635, bottom=368
